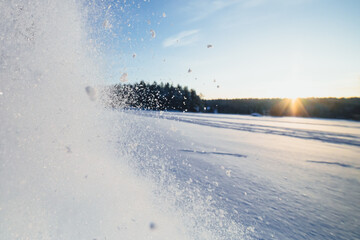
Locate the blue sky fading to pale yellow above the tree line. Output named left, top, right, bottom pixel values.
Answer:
left=93, top=0, right=360, bottom=99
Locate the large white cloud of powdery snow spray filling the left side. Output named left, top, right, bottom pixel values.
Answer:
left=0, top=0, right=242, bottom=240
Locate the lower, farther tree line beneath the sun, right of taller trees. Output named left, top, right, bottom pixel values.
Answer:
left=205, top=98, right=360, bottom=120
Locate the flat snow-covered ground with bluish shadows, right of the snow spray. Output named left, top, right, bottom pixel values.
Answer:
left=115, top=111, right=360, bottom=239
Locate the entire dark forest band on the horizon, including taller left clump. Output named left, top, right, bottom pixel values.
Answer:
left=107, top=81, right=360, bottom=120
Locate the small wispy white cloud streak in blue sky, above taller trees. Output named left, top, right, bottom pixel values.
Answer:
left=163, top=29, right=199, bottom=48
